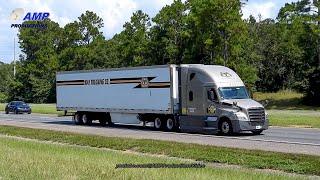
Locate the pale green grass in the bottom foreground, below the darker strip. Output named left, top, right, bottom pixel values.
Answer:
left=0, top=137, right=302, bottom=179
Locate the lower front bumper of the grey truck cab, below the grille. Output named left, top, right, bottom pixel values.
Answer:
left=231, top=120, right=269, bottom=133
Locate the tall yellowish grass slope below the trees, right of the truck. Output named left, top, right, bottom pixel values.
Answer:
left=253, top=90, right=320, bottom=110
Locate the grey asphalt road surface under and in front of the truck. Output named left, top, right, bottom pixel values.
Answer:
left=0, top=112, right=320, bottom=156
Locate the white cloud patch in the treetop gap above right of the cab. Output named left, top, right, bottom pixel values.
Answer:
left=242, top=1, right=277, bottom=19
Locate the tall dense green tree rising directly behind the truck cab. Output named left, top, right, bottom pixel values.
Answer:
left=188, top=0, right=257, bottom=87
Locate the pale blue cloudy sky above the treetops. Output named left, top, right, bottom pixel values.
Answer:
left=0, top=0, right=295, bottom=63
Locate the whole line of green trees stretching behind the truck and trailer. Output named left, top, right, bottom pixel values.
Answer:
left=0, top=0, right=320, bottom=104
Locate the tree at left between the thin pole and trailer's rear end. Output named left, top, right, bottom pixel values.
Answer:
left=15, top=19, right=61, bottom=103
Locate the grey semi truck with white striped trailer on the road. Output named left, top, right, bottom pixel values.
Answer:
left=56, top=64, right=268, bottom=135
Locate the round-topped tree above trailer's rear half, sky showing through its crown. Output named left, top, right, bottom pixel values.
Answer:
left=59, top=11, right=105, bottom=71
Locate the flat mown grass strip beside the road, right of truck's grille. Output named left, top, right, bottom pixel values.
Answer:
left=268, top=110, right=320, bottom=128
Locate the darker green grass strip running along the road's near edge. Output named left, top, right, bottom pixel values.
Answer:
left=0, top=126, right=320, bottom=175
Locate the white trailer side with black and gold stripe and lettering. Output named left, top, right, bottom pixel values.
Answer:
left=56, top=66, right=174, bottom=114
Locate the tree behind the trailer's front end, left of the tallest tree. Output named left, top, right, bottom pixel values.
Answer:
left=151, top=0, right=190, bottom=64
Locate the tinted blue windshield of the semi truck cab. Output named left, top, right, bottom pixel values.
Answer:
left=219, top=86, right=249, bottom=99
